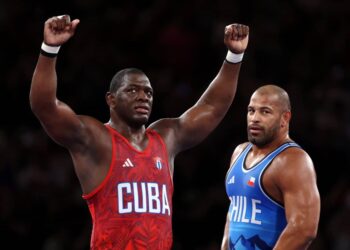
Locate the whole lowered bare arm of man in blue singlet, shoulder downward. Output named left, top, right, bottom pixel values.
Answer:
left=274, top=150, right=320, bottom=250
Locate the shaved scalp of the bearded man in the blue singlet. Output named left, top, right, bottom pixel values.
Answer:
left=252, top=84, right=291, bottom=112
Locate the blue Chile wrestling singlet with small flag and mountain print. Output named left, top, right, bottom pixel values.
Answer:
left=225, top=142, right=300, bottom=250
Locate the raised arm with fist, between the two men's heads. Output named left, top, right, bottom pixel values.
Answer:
left=151, top=24, right=249, bottom=154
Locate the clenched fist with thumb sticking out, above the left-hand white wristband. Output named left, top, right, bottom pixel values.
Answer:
left=44, top=15, right=80, bottom=46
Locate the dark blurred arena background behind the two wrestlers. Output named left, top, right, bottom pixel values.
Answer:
left=0, top=0, right=350, bottom=250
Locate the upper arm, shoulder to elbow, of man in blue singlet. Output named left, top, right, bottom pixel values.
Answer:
left=277, top=150, right=320, bottom=234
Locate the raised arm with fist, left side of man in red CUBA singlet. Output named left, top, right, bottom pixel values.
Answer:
left=29, top=15, right=81, bottom=146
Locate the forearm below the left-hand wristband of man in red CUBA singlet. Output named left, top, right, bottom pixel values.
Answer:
left=29, top=55, right=57, bottom=113
